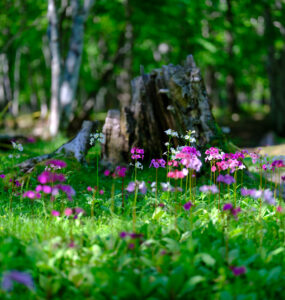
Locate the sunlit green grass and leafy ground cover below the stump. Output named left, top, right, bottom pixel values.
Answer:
left=0, top=139, right=285, bottom=300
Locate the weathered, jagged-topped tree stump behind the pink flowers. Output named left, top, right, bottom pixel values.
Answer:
left=102, top=55, right=224, bottom=164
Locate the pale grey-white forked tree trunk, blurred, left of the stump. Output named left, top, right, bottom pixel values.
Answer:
left=48, top=0, right=93, bottom=136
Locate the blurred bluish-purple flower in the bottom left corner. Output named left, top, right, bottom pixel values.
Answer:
left=2, top=270, right=35, bottom=291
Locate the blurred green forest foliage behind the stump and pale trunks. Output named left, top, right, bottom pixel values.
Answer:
left=0, top=0, right=285, bottom=145
